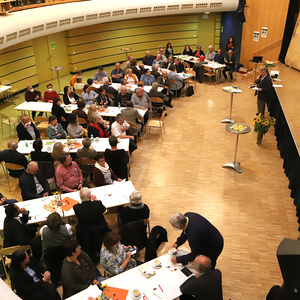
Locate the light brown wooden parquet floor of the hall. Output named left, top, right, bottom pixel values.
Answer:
left=0, top=67, right=298, bottom=300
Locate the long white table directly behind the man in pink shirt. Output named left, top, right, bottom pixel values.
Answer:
left=17, top=138, right=129, bottom=154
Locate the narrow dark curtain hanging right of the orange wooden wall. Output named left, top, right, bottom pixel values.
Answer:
left=278, top=0, right=300, bottom=64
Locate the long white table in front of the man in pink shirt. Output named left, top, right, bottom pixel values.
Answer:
left=0, top=181, right=135, bottom=231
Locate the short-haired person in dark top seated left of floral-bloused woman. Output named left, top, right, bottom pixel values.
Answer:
left=61, top=240, right=105, bottom=299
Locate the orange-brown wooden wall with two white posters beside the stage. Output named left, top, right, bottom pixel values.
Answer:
left=241, top=0, right=289, bottom=68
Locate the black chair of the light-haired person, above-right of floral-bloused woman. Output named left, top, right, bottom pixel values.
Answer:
left=119, top=219, right=149, bottom=251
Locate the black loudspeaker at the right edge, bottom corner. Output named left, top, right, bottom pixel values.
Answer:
left=277, top=239, right=300, bottom=298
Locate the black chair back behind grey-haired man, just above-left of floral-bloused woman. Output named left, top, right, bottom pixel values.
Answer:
left=76, top=226, right=110, bottom=264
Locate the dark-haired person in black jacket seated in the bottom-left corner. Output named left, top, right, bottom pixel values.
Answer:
left=9, top=250, right=61, bottom=300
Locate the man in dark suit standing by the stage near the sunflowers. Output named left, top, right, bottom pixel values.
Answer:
left=255, top=68, right=273, bottom=115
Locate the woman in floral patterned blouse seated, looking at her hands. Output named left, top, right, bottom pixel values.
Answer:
left=100, top=231, right=136, bottom=277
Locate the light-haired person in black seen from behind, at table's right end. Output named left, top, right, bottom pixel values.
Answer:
left=118, top=191, right=150, bottom=225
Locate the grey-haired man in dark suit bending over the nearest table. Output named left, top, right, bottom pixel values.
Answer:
left=169, top=212, right=224, bottom=269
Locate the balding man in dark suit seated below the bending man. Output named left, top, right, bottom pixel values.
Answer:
left=180, top=255, right=223, bottom=300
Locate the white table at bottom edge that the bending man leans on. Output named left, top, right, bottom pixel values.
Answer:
left=101, top=247, right=196, bottom=300
